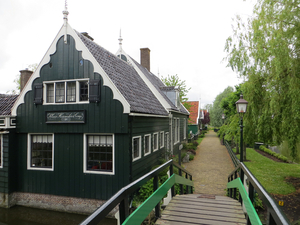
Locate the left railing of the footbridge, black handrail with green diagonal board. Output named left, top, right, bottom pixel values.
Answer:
left=80, top=160, right=193, bottom=225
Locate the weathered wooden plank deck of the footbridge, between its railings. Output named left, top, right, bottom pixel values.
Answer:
left=156, top=194, right=246, bottom=225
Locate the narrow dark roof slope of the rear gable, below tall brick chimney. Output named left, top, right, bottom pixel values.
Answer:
left=131, top=58, right=189, bottom=114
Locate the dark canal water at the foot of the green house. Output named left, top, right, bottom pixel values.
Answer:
left=0, top=206, right=117, bottom=225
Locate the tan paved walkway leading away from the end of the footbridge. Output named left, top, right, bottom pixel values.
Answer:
left=183, top=130, right=234, bottom=195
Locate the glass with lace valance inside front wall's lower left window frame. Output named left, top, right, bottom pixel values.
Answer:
left=31, top=135, right=52, bottom=168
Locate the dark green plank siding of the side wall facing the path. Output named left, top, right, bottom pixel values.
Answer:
left=132, top=116, right=169, bottom=180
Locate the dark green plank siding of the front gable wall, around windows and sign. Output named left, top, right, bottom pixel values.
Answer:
left=16, top=36, right=130, bottom=200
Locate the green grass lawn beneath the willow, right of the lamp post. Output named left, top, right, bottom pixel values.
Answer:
left=237, top=148, right=300, bottom=195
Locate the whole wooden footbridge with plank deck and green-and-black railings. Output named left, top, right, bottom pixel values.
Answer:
left=81, top=150, right=290, bottom=225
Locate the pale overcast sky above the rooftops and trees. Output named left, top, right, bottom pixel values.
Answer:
left=0, top=0, right=255, bottom=107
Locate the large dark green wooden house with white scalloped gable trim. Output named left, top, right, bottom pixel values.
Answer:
left=0, top=11, right=189, bottom=213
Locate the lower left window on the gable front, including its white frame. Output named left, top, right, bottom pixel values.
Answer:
left=27, top=134, right=53, bottom=170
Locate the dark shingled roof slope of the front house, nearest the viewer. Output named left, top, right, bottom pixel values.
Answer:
left=77, top=32, right=168, bottom=115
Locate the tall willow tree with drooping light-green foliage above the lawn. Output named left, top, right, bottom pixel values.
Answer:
left=225, top=0, right=300, bottom=161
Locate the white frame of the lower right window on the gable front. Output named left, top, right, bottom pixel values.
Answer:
left=83, top=133, right=115, bottom=175
